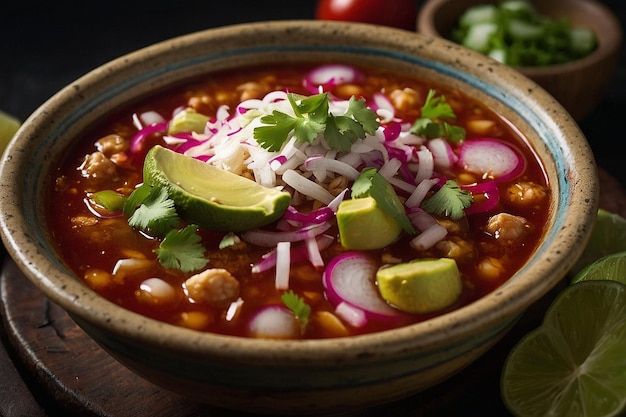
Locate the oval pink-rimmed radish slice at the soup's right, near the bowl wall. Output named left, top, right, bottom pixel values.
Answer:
left=458, top=138, right=526, bottom=181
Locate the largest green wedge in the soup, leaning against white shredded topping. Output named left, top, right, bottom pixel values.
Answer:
left=143, top=146, right=291, bottom=232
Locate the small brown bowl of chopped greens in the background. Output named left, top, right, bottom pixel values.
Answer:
left=417, top=0, right=622, bottom=121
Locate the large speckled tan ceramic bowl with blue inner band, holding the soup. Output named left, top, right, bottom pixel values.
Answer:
left=0, top=21, right=598, bottom=415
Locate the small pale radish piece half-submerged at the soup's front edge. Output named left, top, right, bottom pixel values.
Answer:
left=248, top=305, right=300, bottom=339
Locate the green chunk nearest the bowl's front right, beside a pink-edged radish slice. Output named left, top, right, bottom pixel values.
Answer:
left=376, top=258, right=462, bottom=313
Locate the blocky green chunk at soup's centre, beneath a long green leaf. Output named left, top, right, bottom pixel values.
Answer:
left=337, top=197, right=402, bottom=250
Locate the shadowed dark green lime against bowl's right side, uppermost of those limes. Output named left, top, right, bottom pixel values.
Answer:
left=570, top=209, right=626, bottom=274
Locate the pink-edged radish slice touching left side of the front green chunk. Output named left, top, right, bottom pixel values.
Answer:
left=322, top=251, right=400, bottom=320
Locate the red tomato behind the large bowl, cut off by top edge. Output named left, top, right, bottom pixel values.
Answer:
left=315, top=0, right=417, bottom=31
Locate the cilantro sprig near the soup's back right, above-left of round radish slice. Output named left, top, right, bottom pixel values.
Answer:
left=411, top=89, right=465, bottom=143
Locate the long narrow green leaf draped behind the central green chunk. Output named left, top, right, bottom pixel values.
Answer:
left=351, top=168, right=415, bottom=234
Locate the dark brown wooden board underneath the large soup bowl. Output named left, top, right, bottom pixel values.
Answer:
left=0, top=170, right=626, bottom=417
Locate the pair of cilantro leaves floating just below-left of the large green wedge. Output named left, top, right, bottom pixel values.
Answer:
left=123, top=183, right=208, bottom=272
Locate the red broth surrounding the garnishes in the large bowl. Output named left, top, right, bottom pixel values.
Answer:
left=46, top=66, right=549, bottom=339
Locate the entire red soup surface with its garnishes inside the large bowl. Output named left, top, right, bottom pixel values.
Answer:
left=46, top=64, right=550, bottom=339
